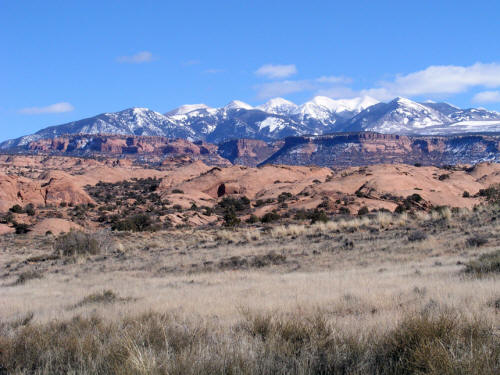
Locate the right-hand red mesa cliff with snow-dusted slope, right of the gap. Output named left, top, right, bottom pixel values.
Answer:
left=262, top=132, right=500, bottom=167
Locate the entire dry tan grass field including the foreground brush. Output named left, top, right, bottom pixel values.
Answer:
left=0, top=205, right=500, bottom=374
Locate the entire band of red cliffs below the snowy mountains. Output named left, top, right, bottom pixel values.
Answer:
left=5, top=132, right=500, bottom=167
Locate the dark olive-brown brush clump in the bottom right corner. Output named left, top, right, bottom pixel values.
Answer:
left=373, top=312, right=500, bottom=375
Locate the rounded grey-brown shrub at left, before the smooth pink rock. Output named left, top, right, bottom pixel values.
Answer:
left=54, top=230, right=108, bottom=257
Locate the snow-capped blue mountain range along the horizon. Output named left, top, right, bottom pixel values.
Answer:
left=0, top=96, right=500, bottom=150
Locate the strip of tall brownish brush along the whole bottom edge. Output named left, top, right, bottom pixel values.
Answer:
left=0, top=311, right=500, bottom=375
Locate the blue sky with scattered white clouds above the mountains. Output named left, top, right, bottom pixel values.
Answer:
left=0, top=0, right=500, bottom=140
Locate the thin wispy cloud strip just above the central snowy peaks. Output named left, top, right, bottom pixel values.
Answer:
left=254, top=76, right=351, bottom=99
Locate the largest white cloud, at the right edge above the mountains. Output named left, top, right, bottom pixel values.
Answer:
left=362, top=63, right=500, bottom=100
